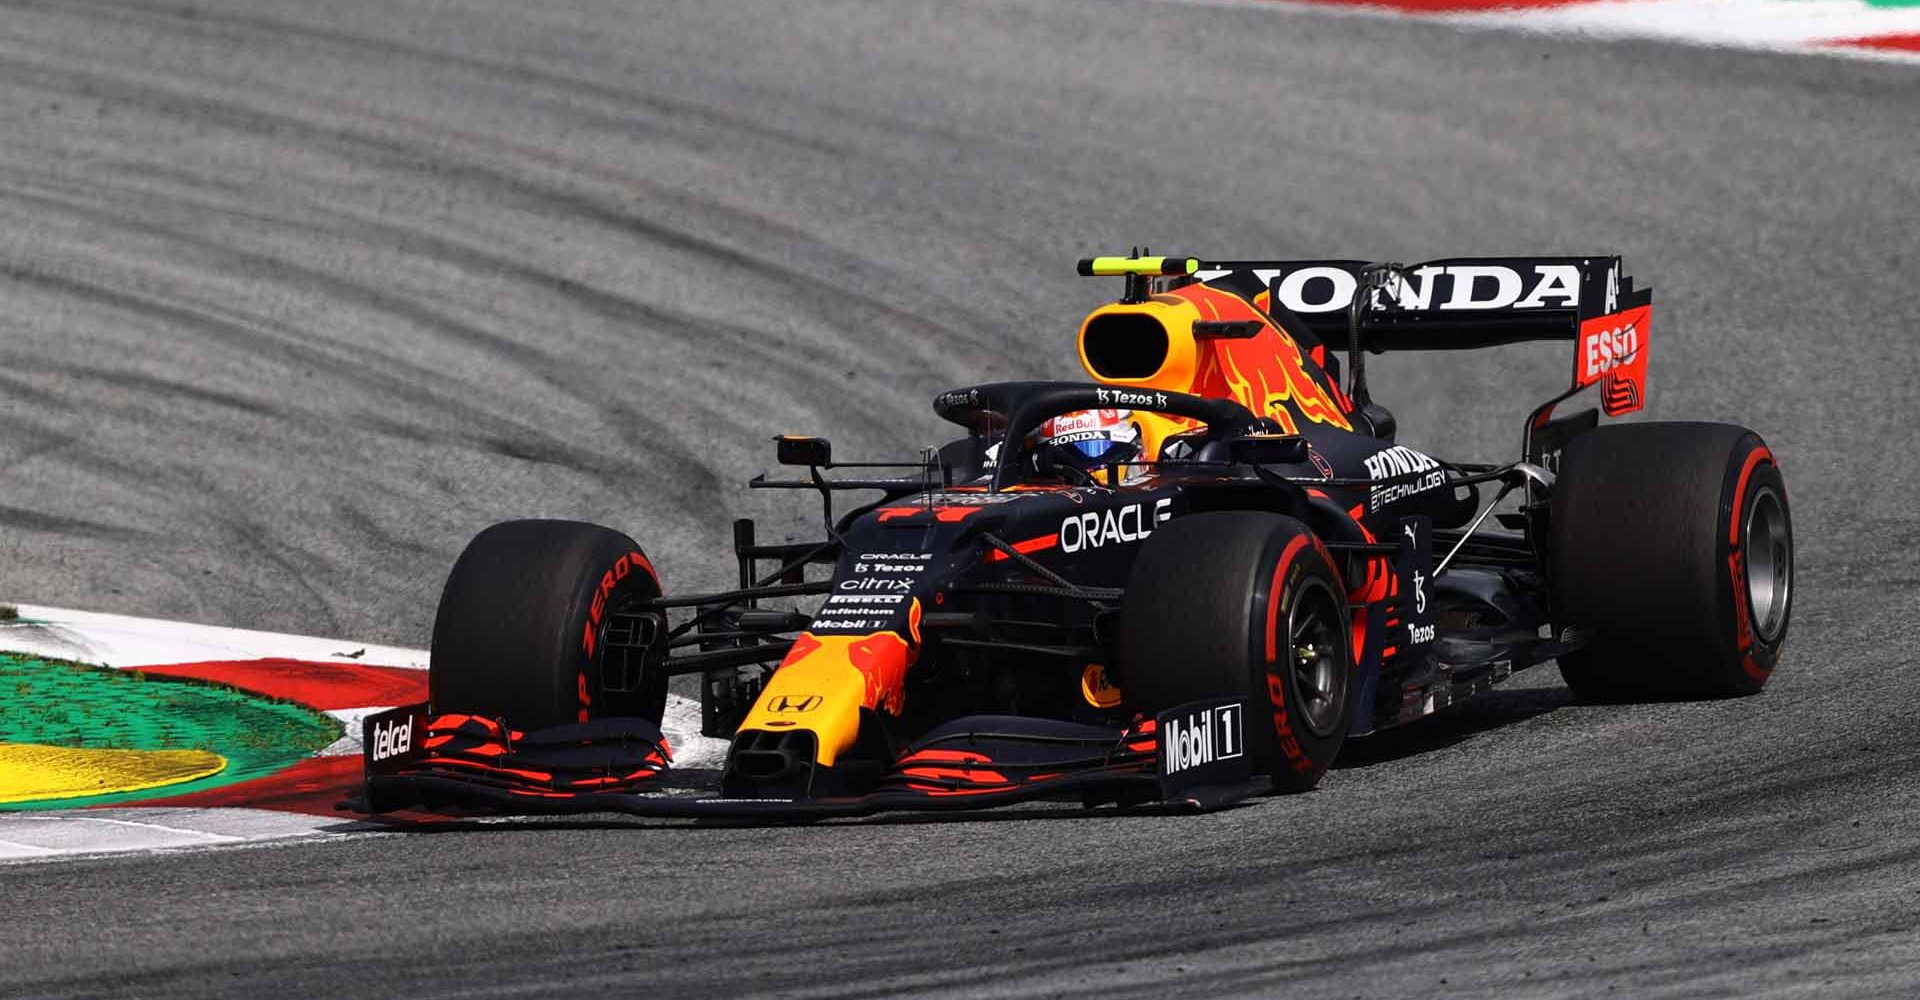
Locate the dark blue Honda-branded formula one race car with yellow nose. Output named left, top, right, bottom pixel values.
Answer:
left=359, top=255, right=1793, bottom=820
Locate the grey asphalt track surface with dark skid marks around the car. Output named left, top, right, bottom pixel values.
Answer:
left=0, top=0, right=1920, bottom=998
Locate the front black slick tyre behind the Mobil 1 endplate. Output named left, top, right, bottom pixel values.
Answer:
left=1117, top=511, right=1354, bottom=793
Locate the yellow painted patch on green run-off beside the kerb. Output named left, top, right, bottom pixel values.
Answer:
left=0, top=743, right=227, bottom=802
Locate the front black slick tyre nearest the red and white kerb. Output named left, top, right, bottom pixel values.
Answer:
left=428, top=520, right=666, bottom=731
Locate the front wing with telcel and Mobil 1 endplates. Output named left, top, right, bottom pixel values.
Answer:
left=349, top=699, right=1263, bottom=821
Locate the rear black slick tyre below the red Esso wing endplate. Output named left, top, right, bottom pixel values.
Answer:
left=1548, top=424, right=1793, bottom=701
